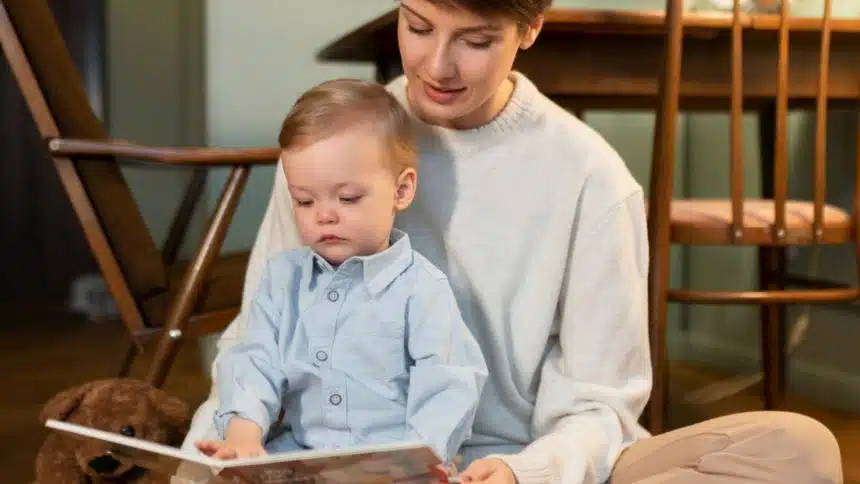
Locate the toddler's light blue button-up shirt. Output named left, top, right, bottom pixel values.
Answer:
left=215, top=229, right=487, bottom=461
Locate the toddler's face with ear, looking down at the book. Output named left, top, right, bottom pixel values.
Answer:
left=281, top=128, right=415, bottom=265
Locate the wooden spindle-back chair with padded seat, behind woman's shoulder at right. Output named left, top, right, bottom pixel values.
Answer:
left=647, top=0, right=860, bottom=432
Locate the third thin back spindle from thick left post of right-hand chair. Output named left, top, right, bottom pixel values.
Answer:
left=812, top=0, right=831, bottom=242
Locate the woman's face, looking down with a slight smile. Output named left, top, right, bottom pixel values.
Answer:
left=397, top=0, right=543, bottom=129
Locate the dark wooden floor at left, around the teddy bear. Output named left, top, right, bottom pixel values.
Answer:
left=0, top=307, right=209, bottom=484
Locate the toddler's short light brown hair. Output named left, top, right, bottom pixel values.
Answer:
left=278, top=79, right=418, bottom=174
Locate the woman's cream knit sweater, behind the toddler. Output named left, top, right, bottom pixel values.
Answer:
left=186, top=72, right=651, bottom=484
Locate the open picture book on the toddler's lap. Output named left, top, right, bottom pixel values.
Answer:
left=45, top=420, right=457, bottom=484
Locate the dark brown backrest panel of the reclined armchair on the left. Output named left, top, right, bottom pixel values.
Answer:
left=0, top=0, right=167, bottom=298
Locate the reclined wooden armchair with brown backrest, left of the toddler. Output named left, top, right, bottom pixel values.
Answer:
left=0, top=0, right=278, bottom=386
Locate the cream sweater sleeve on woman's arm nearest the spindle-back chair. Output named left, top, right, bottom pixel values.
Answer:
left=495, top=190, right=651, bottom=484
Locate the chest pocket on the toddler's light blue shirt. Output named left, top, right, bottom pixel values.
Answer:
left=331, top=321, right=407, bottom=383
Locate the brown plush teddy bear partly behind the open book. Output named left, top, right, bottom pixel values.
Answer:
left=35, top=378, right=190, bottom=484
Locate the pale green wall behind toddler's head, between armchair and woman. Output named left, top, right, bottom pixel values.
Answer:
left=205, top=0, right=394, bottom=255
